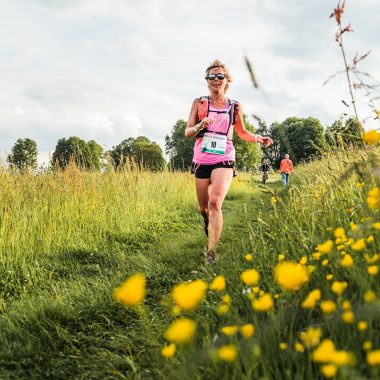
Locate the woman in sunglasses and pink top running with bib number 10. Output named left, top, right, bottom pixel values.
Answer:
left=185, top=60, right=272, bottom=263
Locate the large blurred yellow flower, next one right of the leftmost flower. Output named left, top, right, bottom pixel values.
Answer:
left=172, top=280, right=207, bottom=311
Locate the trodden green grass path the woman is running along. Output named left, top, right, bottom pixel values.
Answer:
left=0, top=176, right=280, bottom=379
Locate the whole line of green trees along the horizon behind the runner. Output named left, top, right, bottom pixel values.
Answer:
left=7, top=115, right=364, bottom=171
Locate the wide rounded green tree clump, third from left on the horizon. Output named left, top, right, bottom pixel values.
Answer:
left=109, top=136, right=166, bottom=171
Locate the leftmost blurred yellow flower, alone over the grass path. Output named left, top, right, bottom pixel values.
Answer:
left=113, top=273, right=146, bottom=307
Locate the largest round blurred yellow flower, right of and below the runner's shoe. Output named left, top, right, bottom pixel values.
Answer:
left=274, top=261, right=309, bottom=291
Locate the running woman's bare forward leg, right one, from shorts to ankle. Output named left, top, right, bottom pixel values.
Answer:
left=208, top=168, right=233, bottom=252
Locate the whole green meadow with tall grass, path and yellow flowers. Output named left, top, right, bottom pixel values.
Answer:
left=0, top=151, right=380, bottom=379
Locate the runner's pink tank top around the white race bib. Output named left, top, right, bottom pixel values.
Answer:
left=193, top=104, right=235, bottom=165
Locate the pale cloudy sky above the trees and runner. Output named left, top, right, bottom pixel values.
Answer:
left=0, top=0, right=380, bottom=164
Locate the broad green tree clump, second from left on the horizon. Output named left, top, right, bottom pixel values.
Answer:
left=52, top=136, right=103, bottom=170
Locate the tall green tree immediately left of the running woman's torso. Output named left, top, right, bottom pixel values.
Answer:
left=165, top=119, right=194, bottom=170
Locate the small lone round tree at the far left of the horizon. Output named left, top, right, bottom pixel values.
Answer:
left=7, top=138, right=38, bottom=171
